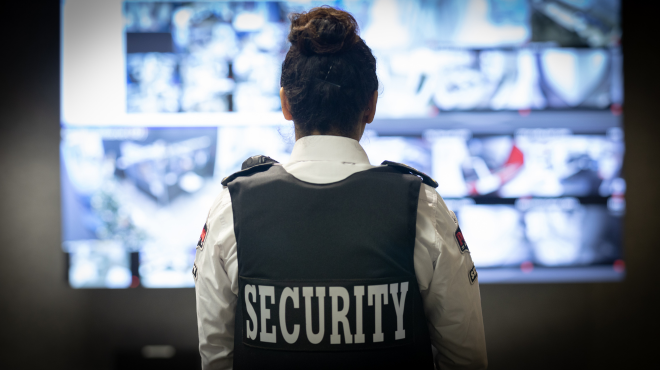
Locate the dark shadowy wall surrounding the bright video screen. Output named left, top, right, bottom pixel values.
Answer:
left=0, top=1, right=660, bottom=369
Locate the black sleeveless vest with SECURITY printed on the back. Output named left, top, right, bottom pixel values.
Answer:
left=224, top=164, right=433, bottom=370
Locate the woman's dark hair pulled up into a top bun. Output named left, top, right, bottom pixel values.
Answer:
left=280, top=6, right=378, bottom=136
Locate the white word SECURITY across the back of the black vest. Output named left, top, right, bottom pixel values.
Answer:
left=242, top=279, right=414, bottom=351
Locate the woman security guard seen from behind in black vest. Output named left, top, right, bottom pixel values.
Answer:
left=193, top=7, right=487, bottom=369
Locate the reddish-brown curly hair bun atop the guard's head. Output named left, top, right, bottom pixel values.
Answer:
left=289, top=6, right=360, bottom=55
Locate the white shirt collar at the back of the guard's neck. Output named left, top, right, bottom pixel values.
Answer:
left=289, top=135, right=369, bottom=164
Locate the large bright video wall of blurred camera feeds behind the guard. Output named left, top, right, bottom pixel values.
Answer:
left=60, top=0, right=626, bottom=288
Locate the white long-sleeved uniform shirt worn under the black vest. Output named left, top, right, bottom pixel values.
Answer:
left=195, top=135, right=488, bottom=370
